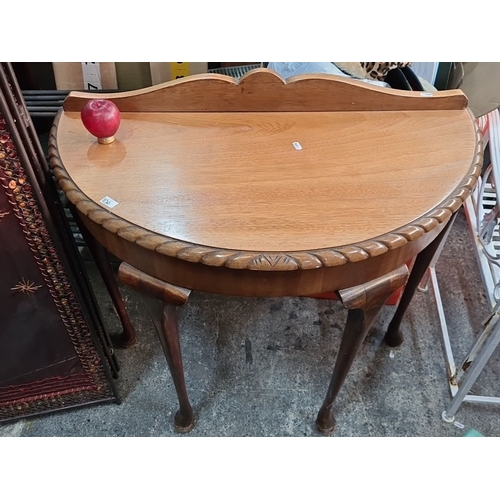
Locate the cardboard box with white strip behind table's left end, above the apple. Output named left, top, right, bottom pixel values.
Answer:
left=52, top=62, right=118, bottom=90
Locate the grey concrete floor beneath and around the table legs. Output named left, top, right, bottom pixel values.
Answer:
left=0, top=212, right=500, bottom=437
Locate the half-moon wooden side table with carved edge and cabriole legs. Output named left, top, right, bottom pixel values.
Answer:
left=50, top=69, right=482, bottom=434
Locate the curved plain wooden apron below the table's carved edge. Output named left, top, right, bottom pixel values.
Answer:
left=70, top=214, right=449, bottom=297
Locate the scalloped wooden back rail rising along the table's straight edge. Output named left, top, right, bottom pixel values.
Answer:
left=64, top=68, right=467, bottom=112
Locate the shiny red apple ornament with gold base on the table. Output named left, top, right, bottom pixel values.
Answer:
left=80, top=99, right=121, bottom=144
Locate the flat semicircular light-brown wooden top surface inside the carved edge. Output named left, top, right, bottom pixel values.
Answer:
left=53, top=110, right=477, bottom=252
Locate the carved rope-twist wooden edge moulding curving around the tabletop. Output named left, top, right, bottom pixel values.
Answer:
left=49, top=112, right=483, bottom=271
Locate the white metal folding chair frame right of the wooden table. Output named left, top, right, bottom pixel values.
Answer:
left=419, top=110, right=500, bottom=423
